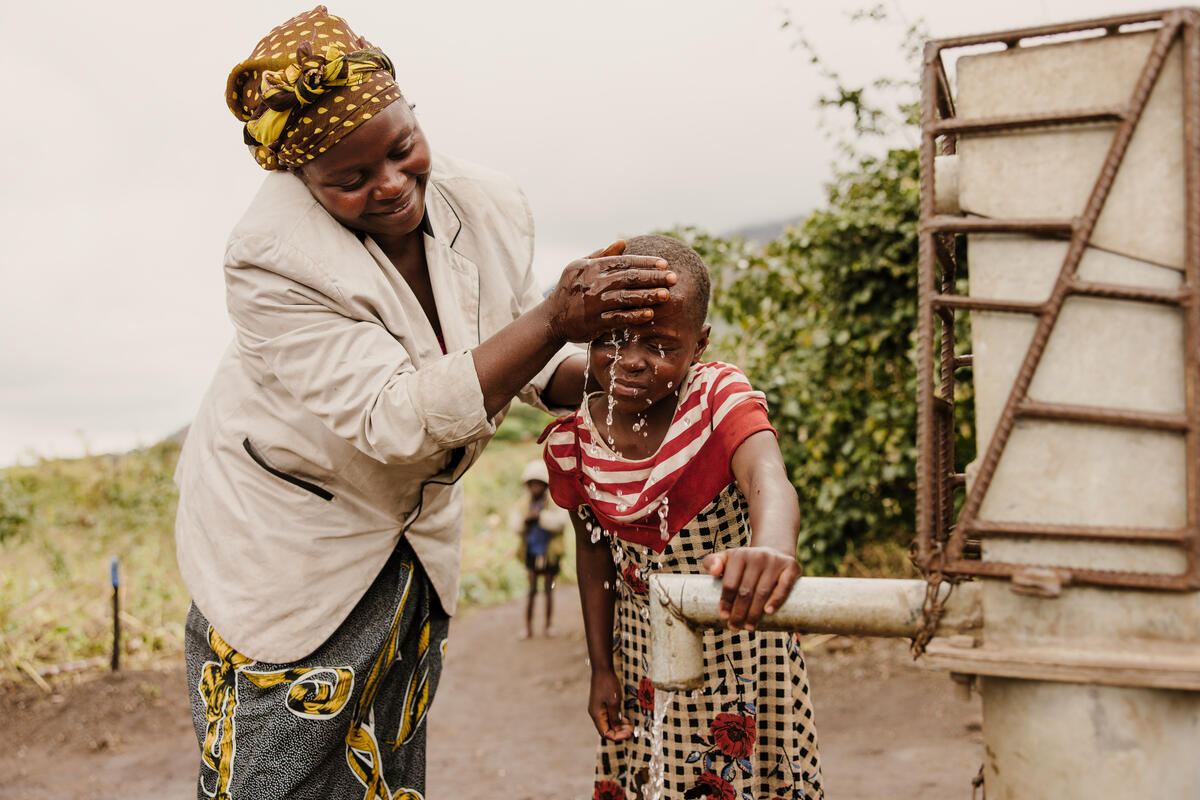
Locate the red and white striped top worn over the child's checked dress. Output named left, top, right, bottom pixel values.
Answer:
left=540, top=361, right=774, bottom=553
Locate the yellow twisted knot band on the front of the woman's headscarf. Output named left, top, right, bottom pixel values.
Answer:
left=246, top=42, right=396, bottom=148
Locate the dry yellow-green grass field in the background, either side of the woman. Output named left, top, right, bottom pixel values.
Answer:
left=0, top=407, right=575, bottom=681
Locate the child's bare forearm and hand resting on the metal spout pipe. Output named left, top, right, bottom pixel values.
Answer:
left=703, top=431, right=800, bottom=631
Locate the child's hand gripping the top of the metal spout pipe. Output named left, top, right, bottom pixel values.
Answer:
left=702, top=547, right=800, bottom=631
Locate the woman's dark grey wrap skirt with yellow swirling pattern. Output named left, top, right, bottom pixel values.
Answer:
left=185, top=541, right=449, bottom=800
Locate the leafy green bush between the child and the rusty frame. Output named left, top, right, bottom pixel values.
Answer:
left=674, top=150, right=973, bottom=573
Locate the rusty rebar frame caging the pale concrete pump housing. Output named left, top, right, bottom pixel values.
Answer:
left=916, top=8, right=1200, bottom=594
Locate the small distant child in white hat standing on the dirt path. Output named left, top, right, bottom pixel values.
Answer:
left=509, top=459, right=566, bottom=639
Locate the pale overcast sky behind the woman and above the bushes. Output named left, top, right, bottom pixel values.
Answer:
left=0, top=0, right=1176, bottom=464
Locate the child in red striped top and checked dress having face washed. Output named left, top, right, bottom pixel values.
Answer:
left=544, top=236, right=822, bottom=800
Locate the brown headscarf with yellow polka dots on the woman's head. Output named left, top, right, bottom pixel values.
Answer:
left=226, top=6, right=400, bottom=169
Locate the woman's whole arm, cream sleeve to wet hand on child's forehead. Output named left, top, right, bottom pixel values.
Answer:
left=226, top=237, right=674, bottom=464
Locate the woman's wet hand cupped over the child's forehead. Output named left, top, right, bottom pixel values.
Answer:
left=546, top=240, right=676, bottom=342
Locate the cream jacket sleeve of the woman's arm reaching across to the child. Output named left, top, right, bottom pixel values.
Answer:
left=226, top=237, right=496, bottom=464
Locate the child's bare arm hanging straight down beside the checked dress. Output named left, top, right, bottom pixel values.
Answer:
left=570, top=511, right=634, bottom=741
